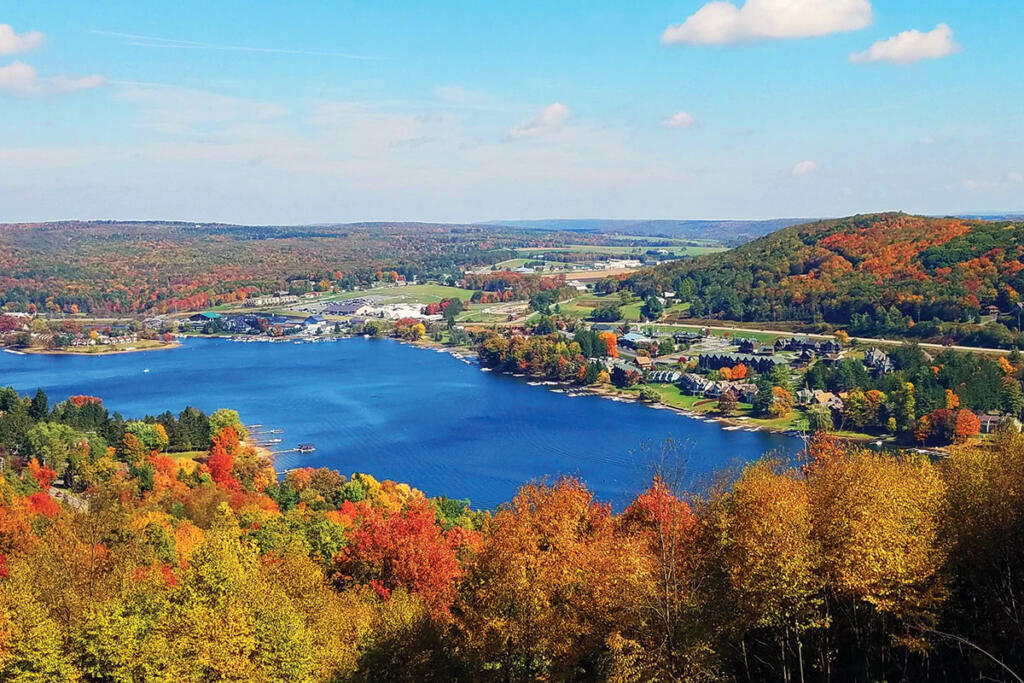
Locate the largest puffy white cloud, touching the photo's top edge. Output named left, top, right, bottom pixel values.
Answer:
left=662, top=0, right=873, bottom=45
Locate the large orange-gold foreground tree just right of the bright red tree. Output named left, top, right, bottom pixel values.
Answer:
left=454, top=479, right=641, bottom=680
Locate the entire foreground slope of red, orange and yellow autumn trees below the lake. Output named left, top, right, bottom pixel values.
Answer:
left=0, top=389, right=1024, bottom=683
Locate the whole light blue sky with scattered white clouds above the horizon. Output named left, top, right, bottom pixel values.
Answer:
left=0, top=0, right=1024, bottom=224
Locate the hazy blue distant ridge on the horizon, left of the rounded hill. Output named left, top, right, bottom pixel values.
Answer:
left=489, top=218, right=810, bottom=246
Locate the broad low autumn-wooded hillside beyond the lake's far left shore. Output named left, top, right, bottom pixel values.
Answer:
left=0, top=221, right=631, bottom=315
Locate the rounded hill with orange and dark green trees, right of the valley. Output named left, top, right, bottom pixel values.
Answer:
left=643, top=213, right=1024, bottom=346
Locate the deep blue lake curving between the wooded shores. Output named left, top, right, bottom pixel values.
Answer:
left=0, top=338, right=800, bottom=508
